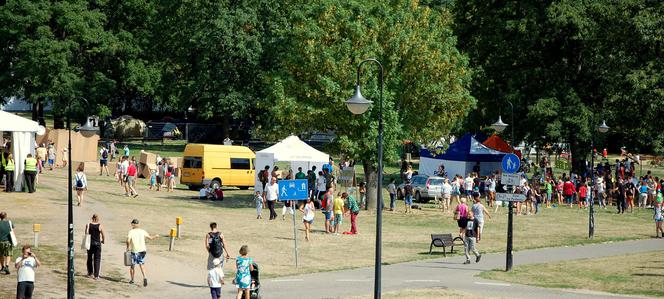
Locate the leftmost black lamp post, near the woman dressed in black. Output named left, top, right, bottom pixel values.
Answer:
left=67, top=98, right=97, bottom=299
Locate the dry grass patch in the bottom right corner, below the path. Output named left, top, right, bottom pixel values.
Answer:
left=480, top=251, right=664, bottom=297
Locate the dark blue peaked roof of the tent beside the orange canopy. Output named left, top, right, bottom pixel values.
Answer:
left=420, top=133, right=506, bottom=162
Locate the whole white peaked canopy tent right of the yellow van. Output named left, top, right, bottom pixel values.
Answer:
left=254, top=135, right=330, bottom=190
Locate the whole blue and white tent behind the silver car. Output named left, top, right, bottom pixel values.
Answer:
left=419, top=133, right=507, bottom=176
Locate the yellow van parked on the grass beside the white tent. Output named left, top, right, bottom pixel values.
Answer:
left=180, top=143, right=256, bottom=190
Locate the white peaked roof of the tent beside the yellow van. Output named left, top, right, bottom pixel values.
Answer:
left=256, top=135, right=330, bottom=162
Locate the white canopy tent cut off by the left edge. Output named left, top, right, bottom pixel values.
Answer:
left=0, top=111, right=45, bottom=191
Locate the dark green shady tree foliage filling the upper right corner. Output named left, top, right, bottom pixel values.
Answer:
left=454, top=0, right=664, bottom=169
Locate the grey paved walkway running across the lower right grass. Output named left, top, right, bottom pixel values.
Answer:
left=262, top=239, right=664, bottom=298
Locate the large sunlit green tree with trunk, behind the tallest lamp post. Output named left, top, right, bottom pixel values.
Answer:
left=257, top=0, right=475, bottom=207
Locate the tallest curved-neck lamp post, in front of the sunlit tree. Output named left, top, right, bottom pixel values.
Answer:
left=346, top=58, right=383, bottom=299
